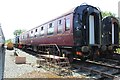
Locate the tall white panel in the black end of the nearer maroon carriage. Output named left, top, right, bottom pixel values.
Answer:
left=89, top=15, right=95, bottom=44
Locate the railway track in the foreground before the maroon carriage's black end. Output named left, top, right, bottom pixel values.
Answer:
left=72, top=60, right=120, bottom=80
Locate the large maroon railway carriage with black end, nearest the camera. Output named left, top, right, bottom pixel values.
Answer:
left=19, top=5, right=102, bottom=59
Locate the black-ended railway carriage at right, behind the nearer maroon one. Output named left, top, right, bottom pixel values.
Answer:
left=101, top=16, right=119, bottom=57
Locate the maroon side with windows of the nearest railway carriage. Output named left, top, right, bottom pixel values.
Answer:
left=20, top=12, right=74, bottom=46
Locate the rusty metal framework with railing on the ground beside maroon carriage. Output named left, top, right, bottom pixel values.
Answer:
left=39, top=44, right=72, bottom=76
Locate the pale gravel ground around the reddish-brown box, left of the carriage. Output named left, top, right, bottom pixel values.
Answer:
left=4, top=50, right=58, bottom=78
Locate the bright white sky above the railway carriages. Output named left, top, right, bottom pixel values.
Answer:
left=0, top=0, right=120, bottom=40
